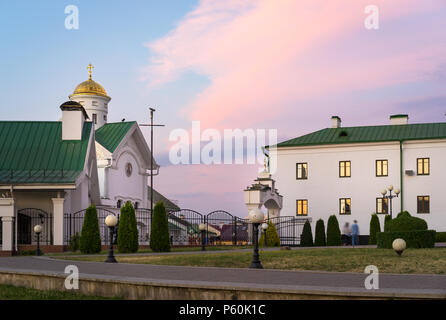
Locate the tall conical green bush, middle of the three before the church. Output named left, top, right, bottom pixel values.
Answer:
left=118, top=201, right=139, bottom=253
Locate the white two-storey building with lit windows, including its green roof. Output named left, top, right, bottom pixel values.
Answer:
left=270, top=115, right=446, bottom=235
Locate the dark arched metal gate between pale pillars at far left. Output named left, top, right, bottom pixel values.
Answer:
left=16, top=208, right=53, bottom=245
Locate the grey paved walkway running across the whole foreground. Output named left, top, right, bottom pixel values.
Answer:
left=0, top=257, right=446, bottom=299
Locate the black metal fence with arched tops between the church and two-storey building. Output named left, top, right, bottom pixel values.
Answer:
left=64, top=207, right=307, bottom=246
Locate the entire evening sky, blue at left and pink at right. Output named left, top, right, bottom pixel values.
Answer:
left=0, top=0, right=446, bottom=216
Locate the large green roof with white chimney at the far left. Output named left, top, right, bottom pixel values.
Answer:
left=0, top=121, right=92, bottom=184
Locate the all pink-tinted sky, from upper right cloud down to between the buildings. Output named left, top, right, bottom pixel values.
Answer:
left=144, top=0, right=446, bottom=216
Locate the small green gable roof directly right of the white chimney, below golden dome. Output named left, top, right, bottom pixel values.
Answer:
left=95, top=121, right=136, bottom=153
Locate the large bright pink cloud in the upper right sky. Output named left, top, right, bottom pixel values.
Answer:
left=145, top=0, right=446, bottom=128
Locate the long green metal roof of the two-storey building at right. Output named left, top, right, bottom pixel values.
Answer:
left=277, top=122, right=446, bottom=148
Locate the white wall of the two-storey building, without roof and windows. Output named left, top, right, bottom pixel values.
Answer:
left=270, top=120, right=446, bottom=235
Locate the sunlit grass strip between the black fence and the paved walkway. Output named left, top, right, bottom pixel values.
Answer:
left=61, top=248, right=446, bottom=274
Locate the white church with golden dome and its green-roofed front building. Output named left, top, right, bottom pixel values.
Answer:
left=0, top=65, right=178, bottom=254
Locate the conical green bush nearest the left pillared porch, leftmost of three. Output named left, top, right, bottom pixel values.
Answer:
left=79, top=205, right=101, bottom=253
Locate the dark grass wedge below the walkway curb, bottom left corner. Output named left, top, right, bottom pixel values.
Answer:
left=0, top=284, right=120, bottom=300
